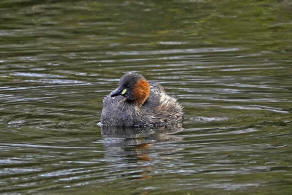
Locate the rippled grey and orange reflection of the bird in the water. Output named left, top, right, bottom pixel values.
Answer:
left=101, top=124, right=182, bottom=179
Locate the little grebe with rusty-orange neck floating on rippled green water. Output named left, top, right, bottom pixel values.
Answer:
left=101, top=72, right=183, bottom=127
